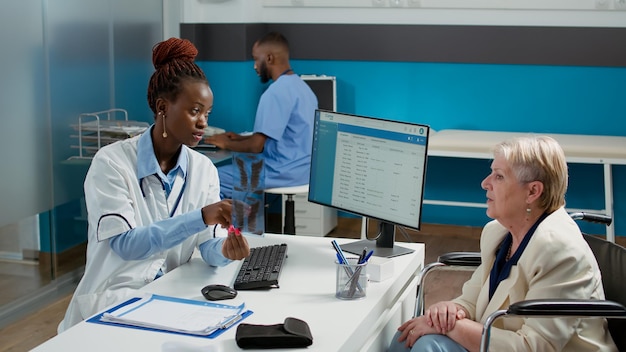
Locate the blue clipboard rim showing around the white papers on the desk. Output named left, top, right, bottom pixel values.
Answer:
left=86, top=295, right=253, bottom=339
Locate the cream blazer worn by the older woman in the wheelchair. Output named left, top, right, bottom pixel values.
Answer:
left=454, top=208, right=617, bottom=352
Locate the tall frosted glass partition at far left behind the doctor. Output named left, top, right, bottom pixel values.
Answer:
left=0, top=0, right=163, bottom=328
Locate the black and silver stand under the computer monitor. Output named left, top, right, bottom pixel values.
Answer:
left=340, top=222, right=414, bottom=258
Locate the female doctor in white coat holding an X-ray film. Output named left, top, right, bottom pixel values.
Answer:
left=58, top=38, right=250, bottom=332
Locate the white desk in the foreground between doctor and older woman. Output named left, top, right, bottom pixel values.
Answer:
left=34, top=234, right=424, bottom=352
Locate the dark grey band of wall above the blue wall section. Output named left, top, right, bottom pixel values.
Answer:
left=181, top=23, right=626, bottom=67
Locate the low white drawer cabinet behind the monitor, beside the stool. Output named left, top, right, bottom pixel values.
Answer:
left=281, top=193, right=337, bottom=237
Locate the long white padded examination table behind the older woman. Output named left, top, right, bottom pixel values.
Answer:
left=424, top=130, right=626, bottom=242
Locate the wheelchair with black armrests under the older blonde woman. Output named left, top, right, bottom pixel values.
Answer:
left=414, top=212, right=626, bottom=351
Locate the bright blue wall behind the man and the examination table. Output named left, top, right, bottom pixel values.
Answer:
left=200, top=60, right=626, bottom=235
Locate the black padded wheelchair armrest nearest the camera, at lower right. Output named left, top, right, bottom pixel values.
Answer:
left=507, top=299, right=626, bottom=318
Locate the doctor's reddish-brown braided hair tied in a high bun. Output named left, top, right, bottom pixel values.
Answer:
left=148, top=38, right=208, bottom=116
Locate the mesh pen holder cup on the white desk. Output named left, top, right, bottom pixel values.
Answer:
left=335, top=258, right=368, bottom=300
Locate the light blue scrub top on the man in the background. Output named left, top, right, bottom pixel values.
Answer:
left=254, top=74, right=317, bottom=188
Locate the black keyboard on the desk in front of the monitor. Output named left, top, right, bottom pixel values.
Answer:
left=233, top=243, right=287, bottom=290
